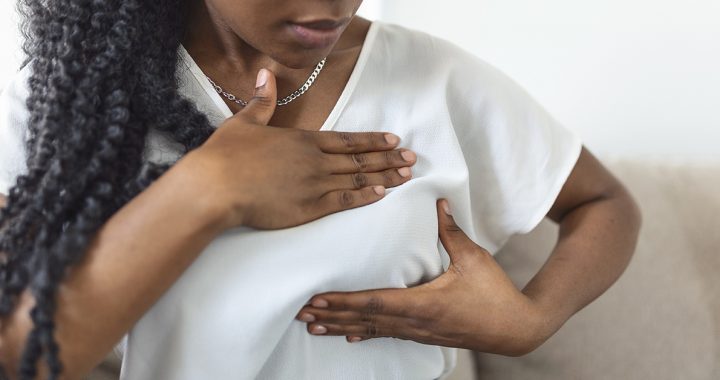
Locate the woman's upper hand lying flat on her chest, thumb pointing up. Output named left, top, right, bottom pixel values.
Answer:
left=176, top=69, right=417, bottom=229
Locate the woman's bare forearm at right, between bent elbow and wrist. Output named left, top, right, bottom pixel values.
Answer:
left=522, top=186, right=641, bottom=345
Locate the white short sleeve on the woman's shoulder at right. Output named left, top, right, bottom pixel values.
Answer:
left=448, top=42, right=582, bottom=249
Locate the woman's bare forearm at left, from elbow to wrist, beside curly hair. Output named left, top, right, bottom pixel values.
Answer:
left=0, top=153, right=224, bottom=379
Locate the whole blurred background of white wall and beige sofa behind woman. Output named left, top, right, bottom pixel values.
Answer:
left=0, top=0, right=720, bottom=380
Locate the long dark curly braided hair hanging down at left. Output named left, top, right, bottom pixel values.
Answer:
left=0, top=0, right=213, bottom=379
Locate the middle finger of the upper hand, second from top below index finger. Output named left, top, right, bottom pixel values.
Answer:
left=327, top=149, right=417, bottom=174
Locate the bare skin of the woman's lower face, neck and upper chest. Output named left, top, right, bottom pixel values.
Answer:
left=184, top=0, right=370, bottom=130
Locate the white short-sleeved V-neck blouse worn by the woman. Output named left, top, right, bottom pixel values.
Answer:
left=0, top=21, right=582, bottom=380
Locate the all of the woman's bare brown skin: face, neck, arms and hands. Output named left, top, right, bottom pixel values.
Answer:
left=0, top=0, right=640, bottom=379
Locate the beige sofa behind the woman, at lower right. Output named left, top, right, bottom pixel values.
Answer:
left=91, top=162, right=720, bottom=380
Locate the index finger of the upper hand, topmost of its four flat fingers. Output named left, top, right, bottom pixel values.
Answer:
left=312, top=131, right=400, bottom=153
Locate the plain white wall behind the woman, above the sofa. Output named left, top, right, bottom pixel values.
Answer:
left=0, top=0, right=720, bottom=162
